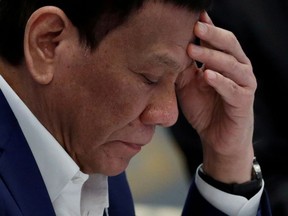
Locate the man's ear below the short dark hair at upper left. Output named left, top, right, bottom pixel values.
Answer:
left=24, top=6, right=72, bottom=84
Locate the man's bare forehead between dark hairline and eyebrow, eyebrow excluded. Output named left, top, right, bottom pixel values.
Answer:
left=125, top=1, right=200, bottom=47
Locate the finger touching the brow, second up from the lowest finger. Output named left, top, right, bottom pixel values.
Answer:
left=187, top=44, right=256, bottom=87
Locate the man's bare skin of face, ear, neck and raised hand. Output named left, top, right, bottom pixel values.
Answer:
left=0, top=2, right=256, bottom=183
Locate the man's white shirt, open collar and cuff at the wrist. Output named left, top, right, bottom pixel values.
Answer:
left=0, top=75, right=264, bottom=216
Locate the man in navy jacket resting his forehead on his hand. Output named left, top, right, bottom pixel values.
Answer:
left=0, top=0, right=270, bottom=216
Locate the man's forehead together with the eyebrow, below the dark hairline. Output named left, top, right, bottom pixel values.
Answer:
left=116, top=1, right=199, bottom=70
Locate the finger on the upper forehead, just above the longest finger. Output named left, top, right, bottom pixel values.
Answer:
left=194, top=21, right=250, bottom=64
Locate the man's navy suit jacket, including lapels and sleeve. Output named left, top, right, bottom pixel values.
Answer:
left=0, top=90, right=269, bottom=216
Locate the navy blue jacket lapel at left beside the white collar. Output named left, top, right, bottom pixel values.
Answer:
left=0, top=90, right=55, bottom=216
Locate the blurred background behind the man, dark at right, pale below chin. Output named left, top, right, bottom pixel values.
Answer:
left=128, top=0, right=288, bottom=216
